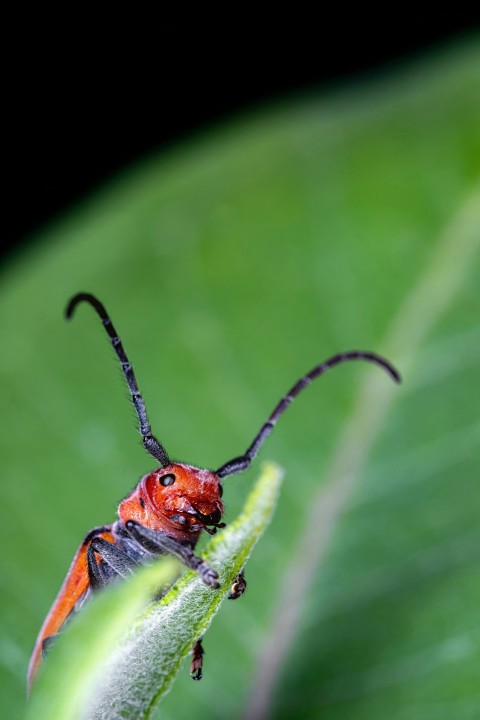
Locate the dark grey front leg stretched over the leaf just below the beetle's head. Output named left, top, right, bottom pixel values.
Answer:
left=125, top=520, right=220, bottom=588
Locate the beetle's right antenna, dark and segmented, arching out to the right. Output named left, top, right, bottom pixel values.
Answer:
left=215, top=350, right=400, bottom=478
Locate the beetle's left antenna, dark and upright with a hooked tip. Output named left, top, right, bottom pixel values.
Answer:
left=65, top=293, right=170, bottom=467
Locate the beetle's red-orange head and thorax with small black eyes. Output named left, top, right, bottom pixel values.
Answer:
left=118, top=463, right=224, bottom=540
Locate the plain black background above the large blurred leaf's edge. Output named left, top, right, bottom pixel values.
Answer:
left=3, top=11, right=479, bottom=264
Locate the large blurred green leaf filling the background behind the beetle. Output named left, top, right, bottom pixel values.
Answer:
left=0, top=42, right=480, bottom=720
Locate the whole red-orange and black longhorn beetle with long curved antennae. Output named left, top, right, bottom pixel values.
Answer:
left=28, top=293, right=400, bottom=687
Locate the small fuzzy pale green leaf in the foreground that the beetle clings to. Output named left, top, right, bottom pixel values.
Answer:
left=27, top=464, right=282, bottom=720
